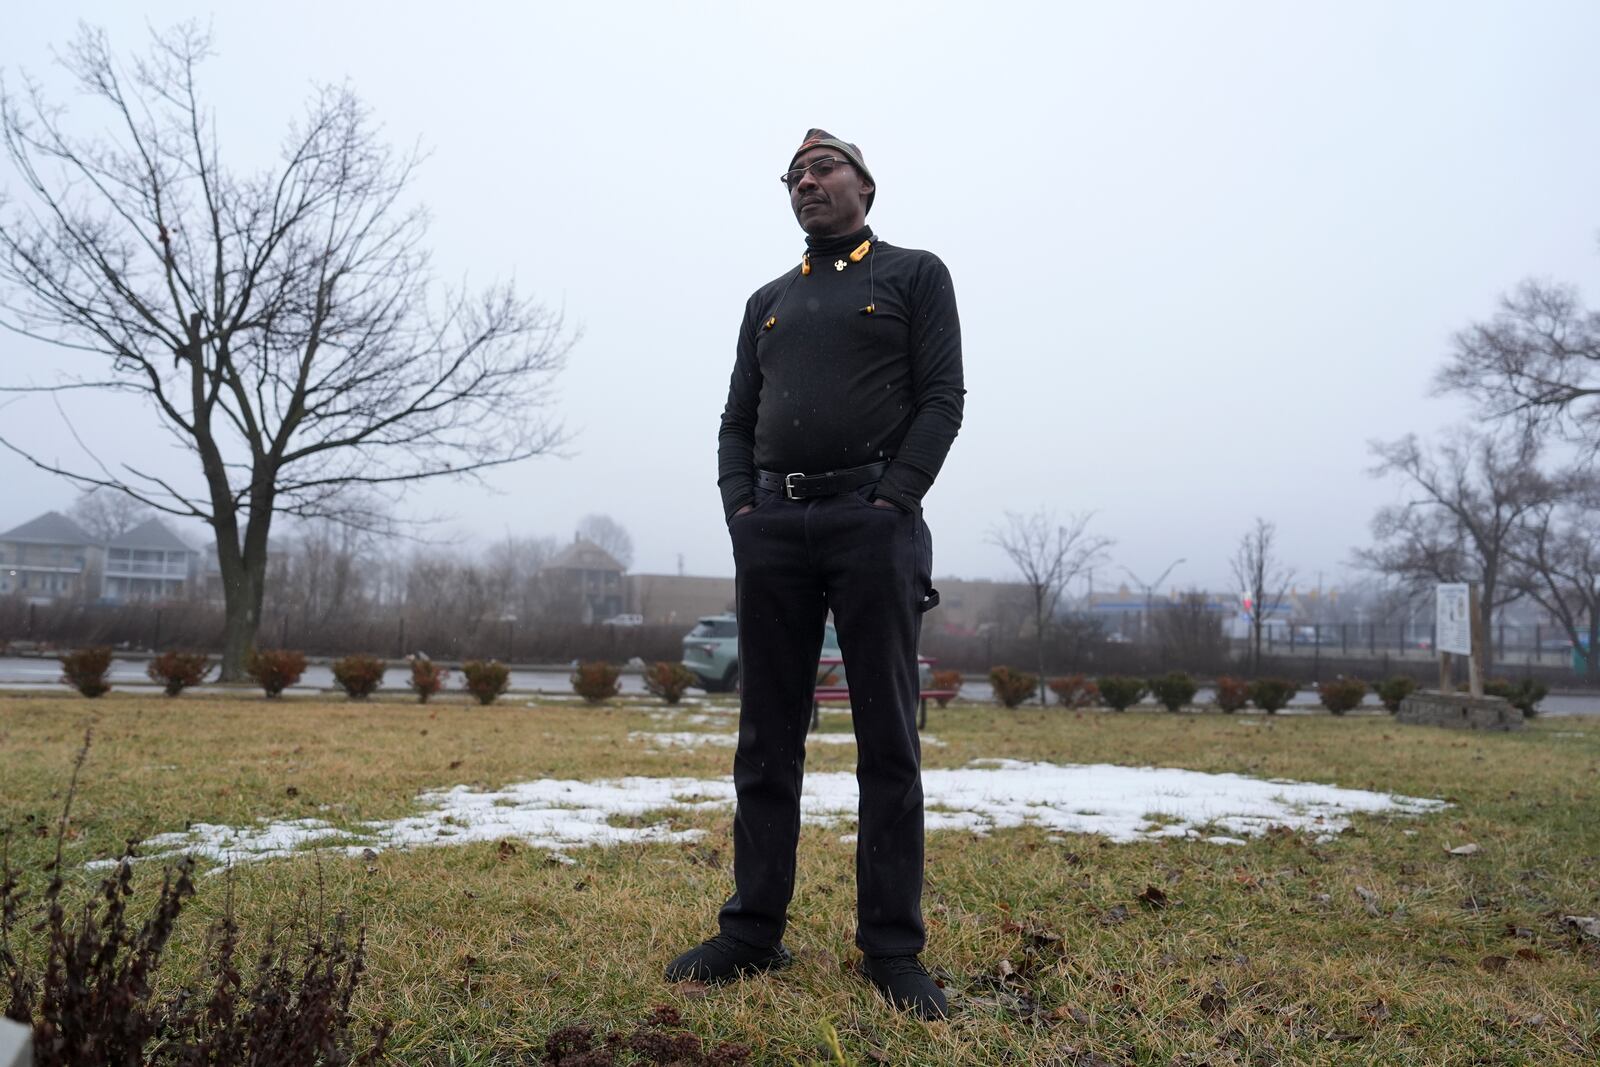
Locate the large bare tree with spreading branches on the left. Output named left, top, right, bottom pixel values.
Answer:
left=0, top=24, right=571, bottom=678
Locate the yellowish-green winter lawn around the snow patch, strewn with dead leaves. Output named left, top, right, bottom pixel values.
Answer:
left=0, top=694, right=1600, bottom=1067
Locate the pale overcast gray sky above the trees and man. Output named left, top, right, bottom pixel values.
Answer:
left=0, top=0, right=1600, bottom=589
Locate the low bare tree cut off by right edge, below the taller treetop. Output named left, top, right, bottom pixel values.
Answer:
left=1512, top=472, right=1600, bottom=685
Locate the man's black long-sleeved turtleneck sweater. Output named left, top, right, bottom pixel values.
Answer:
left=717, top=227, right=966, bottom=517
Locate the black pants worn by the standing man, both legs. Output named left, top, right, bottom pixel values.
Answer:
left=718, top=486, right=933, bottom=957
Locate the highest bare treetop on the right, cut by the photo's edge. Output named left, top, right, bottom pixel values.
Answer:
left=1435, top=280, right=1600, bottom=453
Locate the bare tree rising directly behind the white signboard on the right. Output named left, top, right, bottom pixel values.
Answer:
left=1355, top=427, right=1555, bottom=672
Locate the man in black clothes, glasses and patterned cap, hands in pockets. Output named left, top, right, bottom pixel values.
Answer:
left=667, top=130, right=965, bottom=1019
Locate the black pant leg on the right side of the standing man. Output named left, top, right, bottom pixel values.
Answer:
left=819, top=490, right=933, bottom=957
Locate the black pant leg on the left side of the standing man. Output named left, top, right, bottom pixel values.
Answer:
left=718, top=494, right=827, bottom=945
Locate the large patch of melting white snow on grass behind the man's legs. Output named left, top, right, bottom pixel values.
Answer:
left=101, top=758, right=1446, bottom=865
